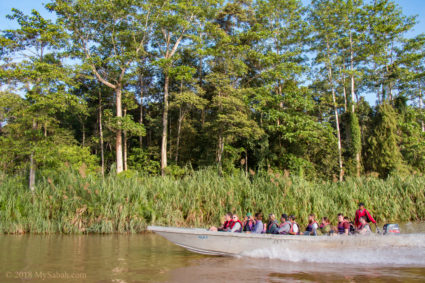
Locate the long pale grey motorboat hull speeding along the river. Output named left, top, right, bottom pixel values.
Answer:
left=148, top=226, right=417, bottom=256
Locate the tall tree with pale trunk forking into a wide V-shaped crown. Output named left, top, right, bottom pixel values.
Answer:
left=48, top=0, right=156, bottom=173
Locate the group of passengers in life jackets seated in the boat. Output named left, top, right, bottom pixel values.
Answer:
left=210, top=203, right=376, bottom=236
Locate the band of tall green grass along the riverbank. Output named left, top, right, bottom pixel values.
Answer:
left=0, top=170, right=425, bottom=233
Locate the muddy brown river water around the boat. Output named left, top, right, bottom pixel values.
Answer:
left=0, top=223, right=425, bottom=283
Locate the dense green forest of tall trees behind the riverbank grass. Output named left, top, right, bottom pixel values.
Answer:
left=0, top=0, right=425, bottom=186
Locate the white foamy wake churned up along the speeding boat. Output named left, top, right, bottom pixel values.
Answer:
left=243, top=234, right=425, bottom=267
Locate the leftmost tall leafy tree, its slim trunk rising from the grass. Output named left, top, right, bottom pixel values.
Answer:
left=2, top=9, right=73, bottom=190
